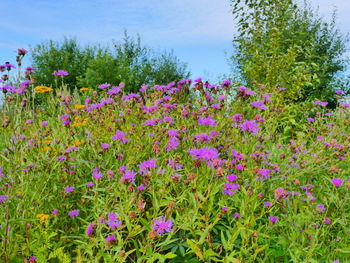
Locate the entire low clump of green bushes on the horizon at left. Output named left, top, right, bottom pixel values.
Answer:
left=31, top=33, right=189, bottom=92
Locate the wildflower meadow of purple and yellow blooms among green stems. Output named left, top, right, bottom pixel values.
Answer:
left=0, top=57, right=350, bottom=263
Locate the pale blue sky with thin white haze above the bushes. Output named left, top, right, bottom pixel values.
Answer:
left=0, top=0, right=350, bottom=80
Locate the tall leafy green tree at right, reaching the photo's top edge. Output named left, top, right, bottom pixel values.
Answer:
left=231, top=0, right=347, bottom=102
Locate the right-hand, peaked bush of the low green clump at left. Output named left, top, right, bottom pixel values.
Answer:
left=79, top=32, right=189, bottom=92
